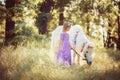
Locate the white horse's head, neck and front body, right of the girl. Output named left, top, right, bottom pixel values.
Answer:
left=70, top=25, right=94, bottom=65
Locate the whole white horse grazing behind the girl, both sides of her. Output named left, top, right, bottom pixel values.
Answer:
left=51, top=25, right=94, bottom=65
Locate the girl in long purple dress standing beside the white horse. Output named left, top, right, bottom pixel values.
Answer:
left=57, top=22, right=71, bottom=65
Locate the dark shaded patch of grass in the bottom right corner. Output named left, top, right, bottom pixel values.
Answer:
left=83, top=68, right=120, bottom=80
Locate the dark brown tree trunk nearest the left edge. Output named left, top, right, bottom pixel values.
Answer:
left=5, top=0, right=15, bottom=45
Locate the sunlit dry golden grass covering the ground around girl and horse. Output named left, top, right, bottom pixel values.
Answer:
left=0, top=39, right=120, bottom=80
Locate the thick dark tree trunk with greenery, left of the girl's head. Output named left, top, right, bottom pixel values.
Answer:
left=36, top=0, right=54, bottom=34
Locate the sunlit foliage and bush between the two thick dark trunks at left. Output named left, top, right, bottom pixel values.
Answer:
left=3, top=0, right=42, bottom=45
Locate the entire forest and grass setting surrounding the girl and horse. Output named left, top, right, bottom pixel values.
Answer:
left=0, top=0, right=120, bottom=80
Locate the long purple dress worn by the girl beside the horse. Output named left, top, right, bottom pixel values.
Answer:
left=57, top=33, right=71, bottom=65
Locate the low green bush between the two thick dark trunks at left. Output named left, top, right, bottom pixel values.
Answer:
left=11, top=25, right=44, bottom=46
